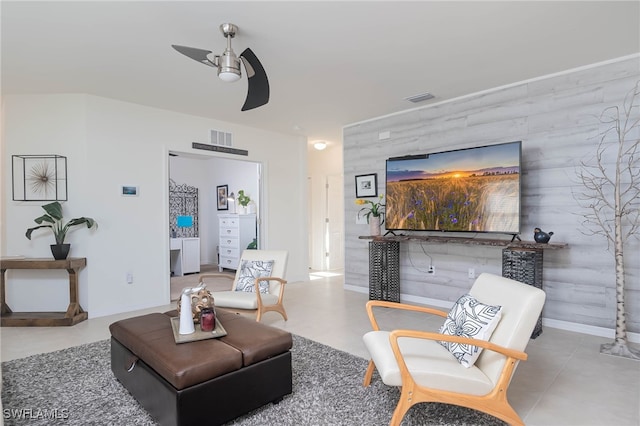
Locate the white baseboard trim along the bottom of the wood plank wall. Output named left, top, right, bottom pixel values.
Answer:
left=344, top=284, right=640, bottom=343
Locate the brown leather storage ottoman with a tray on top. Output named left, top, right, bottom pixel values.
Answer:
left=109, top=309, right=293, bottom=425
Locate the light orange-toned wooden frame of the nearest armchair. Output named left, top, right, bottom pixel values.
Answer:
left=363, top=300, right=527, bottom=426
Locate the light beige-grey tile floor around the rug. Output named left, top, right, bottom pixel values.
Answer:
left=0, top=274, right=640, bottom=426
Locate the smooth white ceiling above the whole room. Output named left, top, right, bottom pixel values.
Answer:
left=1, top=1, right=640, bottom=144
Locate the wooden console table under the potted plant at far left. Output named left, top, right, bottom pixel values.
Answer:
left=0, top=257, right=88, bottom=327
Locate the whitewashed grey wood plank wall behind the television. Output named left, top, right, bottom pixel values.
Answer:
left=343, top=55, right=640, bottom=333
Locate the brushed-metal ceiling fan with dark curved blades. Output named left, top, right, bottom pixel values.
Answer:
left=171, top=24, right=269, bottom=111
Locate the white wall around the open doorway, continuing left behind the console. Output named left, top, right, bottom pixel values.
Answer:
left=2, top=95, right=308, bottom=317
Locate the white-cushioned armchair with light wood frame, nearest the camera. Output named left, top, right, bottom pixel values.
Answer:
left=363, top=273, right=545, bottom=425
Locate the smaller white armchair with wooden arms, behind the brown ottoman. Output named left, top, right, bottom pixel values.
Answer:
left=198, top=250, right=288, bottom=322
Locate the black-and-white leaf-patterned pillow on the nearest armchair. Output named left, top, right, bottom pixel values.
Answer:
left=440, top=294, right=502, bottom=368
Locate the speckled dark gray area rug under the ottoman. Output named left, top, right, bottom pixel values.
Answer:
left=2, top=335, right=504, bottom=426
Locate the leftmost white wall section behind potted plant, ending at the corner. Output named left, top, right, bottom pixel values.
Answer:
left=0, top=95, right=89, bottom=312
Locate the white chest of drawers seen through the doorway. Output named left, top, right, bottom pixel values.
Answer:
left=218, top=214, right=256, bottom=272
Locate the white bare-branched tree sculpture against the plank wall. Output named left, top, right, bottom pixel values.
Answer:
left=576, top=81, right=640, bottom=359
